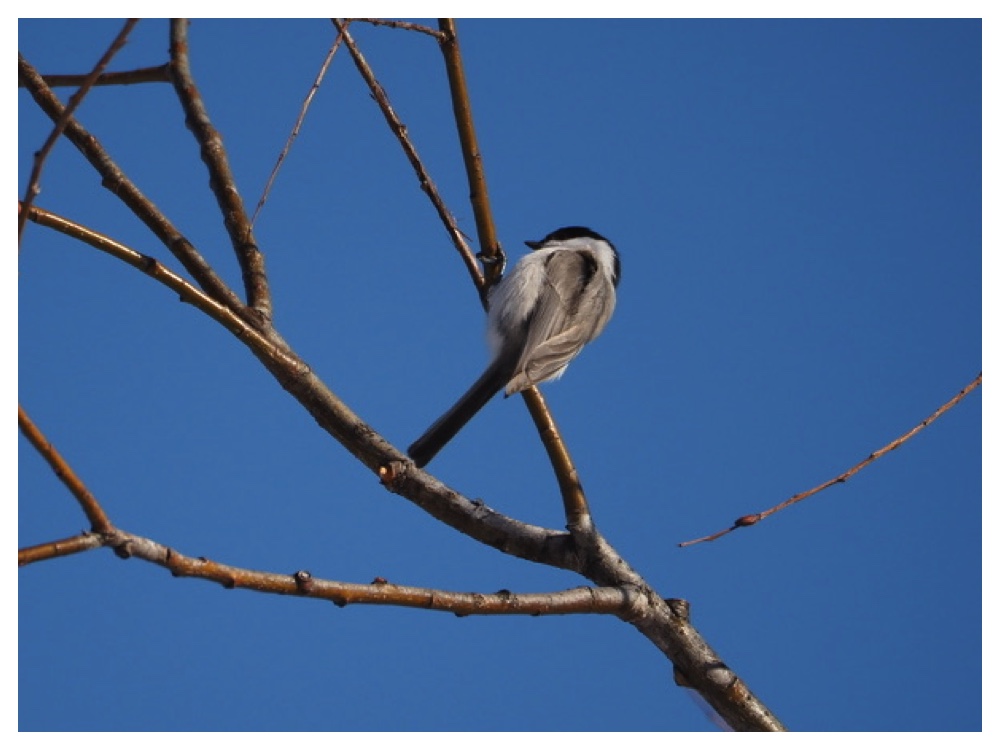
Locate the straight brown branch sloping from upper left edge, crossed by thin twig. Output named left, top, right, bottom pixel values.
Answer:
left=17, top=54, right=252, bottom=318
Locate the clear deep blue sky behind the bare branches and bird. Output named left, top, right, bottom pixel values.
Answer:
left=17, top=19, right=982, bottom=731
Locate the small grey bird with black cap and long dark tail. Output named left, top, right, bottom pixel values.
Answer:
left=407, top=227, right=621, bottom=466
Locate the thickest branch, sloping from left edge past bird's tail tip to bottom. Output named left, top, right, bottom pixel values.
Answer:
left=29, top=201, right=783, bottom=731
